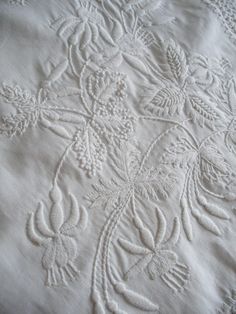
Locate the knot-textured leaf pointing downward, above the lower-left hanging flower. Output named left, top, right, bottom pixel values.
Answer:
left=72, top=126, right=107, bottom=176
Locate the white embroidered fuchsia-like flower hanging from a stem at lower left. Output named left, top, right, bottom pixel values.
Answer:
left=27, top=184, right=87, bottom=286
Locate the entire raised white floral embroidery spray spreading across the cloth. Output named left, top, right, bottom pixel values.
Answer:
left=0, top=0, right=236, bottom=314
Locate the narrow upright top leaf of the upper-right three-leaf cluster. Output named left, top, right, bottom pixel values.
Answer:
left=166, top=41, right=188, bottom=83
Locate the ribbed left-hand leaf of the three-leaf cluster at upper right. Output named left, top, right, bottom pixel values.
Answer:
left=145, top=87, right=186, bottom=116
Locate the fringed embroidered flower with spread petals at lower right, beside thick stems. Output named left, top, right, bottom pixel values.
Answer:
left=119, top=208, right=189, bottom=292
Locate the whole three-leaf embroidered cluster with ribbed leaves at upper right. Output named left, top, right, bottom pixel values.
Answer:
left=145, top=41, right=221, bottom=129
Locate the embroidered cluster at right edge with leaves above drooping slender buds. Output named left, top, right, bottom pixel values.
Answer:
left=161, top=137, right=236, bottom=241
